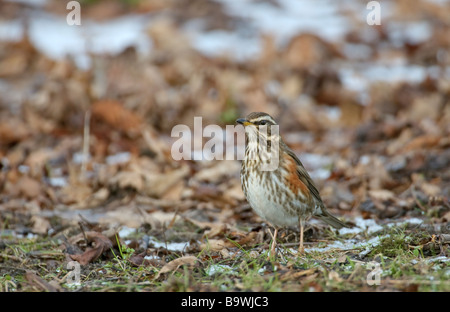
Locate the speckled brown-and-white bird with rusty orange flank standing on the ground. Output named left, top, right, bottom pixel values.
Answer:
left=236, top=112, right=349, bottom=257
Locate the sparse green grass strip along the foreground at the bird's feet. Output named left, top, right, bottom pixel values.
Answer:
left=0, top=221, right=450, bottom=292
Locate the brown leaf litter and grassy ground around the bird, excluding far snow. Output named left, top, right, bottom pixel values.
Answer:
left=0, top=0, right=450, bottom=291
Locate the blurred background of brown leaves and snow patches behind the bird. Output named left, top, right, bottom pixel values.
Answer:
left=0, top=0, right=450, bottom=233
